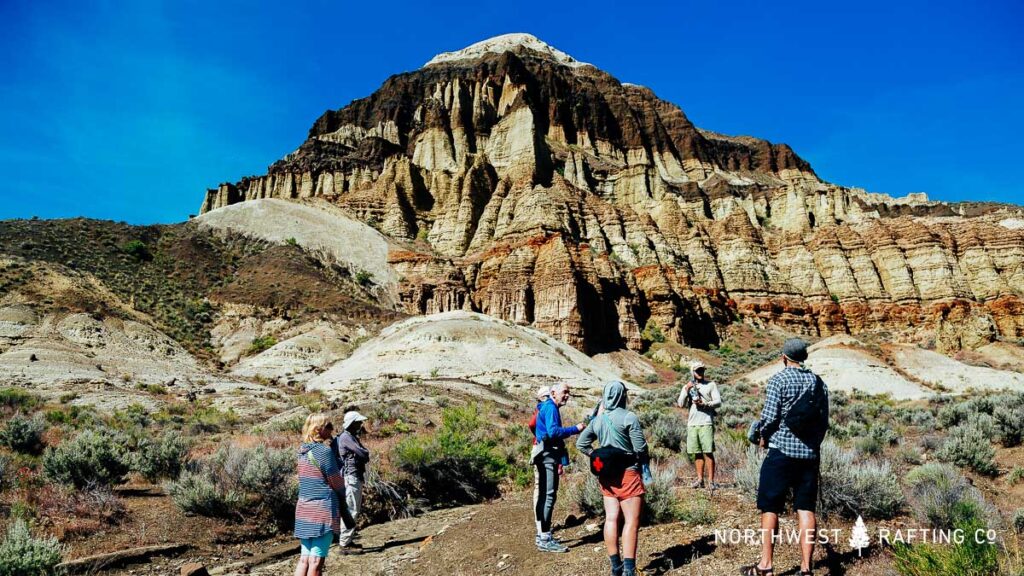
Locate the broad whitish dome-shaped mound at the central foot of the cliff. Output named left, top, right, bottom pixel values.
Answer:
left=307, top=312, right=620, bottom=392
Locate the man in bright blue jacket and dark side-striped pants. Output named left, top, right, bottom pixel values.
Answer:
left=530, top=382, right=584, bottom=552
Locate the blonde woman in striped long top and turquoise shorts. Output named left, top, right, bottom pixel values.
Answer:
left=295, top=413, right=355, bottom=576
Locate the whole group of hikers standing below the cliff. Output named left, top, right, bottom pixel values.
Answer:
left=295, top=338, right=828, bottom=576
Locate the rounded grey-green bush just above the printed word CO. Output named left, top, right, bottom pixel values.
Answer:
left=905, top=462, right=994, bottom=530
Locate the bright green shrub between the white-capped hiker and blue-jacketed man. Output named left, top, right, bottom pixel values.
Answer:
left=391, top=405, right=508, bottom=503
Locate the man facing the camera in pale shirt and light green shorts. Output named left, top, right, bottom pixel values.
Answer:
left=676, top=360, right=722, bottom=483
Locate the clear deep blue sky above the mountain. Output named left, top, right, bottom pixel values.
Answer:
left=0, top=0, right=1024, bottom=223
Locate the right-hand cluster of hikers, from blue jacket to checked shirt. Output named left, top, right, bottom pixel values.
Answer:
left=529, top=338, right=828, bottom=576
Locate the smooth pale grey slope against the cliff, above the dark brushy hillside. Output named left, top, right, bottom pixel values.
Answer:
left=196, top=198, right=397, bottom=303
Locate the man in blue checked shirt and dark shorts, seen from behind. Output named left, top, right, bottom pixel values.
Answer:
left=740, top=338, right=828, bottom=576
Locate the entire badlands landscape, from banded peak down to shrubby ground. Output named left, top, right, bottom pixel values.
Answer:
left=0, top=34, right=1024, bottom=576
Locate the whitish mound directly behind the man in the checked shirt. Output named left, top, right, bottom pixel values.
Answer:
left=745, top=335, right=932, bottom=400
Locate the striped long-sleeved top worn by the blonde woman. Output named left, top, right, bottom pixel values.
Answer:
left=295, top=442, right=345, bottom=538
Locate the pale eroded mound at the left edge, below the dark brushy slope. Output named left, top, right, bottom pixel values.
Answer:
left=0, top=303, right=283, bottom=414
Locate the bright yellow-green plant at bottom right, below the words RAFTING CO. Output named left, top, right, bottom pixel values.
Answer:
left=893, top=502, right=999, bottom=576
